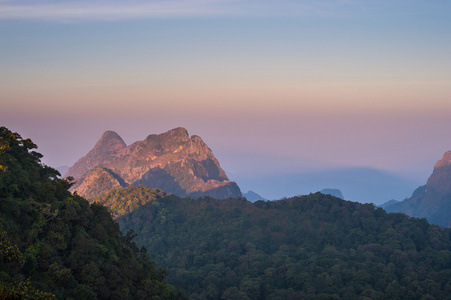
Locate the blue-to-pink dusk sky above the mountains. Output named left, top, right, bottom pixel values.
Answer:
left=0, top=0, right=451, bottom=199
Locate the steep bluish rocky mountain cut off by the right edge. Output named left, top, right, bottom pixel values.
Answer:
left=387, top=151, right=451, bottom=227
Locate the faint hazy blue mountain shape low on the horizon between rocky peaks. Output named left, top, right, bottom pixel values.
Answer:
left=237, top=168, right=419, bottom=204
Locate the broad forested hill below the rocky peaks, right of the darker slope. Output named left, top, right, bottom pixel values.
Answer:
left=113, top=188, right=451, bottom=299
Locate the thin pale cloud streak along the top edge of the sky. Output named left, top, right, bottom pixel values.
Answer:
left=0, top=0, right=355, bottom=21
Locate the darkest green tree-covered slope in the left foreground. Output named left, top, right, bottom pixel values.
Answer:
left=0, top=127, right=185, bottom=299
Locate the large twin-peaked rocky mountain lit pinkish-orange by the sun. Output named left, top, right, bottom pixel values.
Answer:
left=65, top=127, right=241, bottom=199
